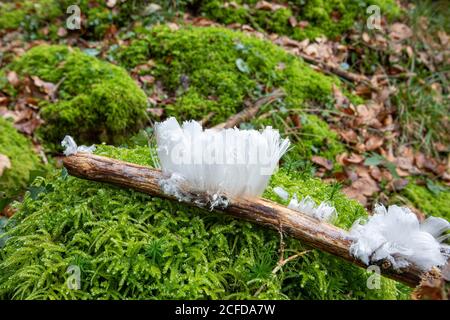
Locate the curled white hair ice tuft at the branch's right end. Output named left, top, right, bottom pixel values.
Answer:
left=350, top=205, right=450, bottom=271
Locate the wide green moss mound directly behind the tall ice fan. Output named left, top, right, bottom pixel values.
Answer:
left=117, top=26, right=338, bottom=123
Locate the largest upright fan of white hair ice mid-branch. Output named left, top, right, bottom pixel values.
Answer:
left=155, top=118, right=289, bottom=196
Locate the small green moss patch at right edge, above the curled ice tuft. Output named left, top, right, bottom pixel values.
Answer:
left=402, top=182, right=450, bottom=220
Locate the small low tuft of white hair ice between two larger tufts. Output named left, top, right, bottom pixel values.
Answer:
left=288, top=194, right=337, bottom=222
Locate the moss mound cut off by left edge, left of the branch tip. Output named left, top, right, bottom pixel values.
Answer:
left=0, top=117, right=42, bottom=198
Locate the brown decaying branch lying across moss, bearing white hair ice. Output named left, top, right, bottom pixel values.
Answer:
left=63, top=153, right=446, bottom=286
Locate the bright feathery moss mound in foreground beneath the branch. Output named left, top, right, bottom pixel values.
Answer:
left=0, top=146, right=408, bottom=299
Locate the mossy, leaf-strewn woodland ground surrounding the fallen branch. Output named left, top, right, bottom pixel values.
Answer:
left=0, top=0, right=450, bottom=299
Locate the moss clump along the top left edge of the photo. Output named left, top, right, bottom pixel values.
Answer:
left=0, top=0, right=190, bottom=39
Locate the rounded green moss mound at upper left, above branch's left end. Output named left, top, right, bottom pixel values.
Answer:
left=6, top=45, right=147, bottom=148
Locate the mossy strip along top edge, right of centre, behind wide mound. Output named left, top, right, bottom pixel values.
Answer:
left=200, top=0, right=400, bottom=40
